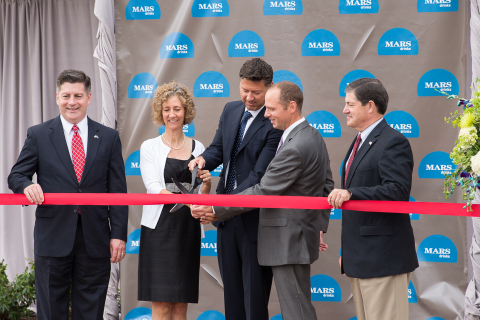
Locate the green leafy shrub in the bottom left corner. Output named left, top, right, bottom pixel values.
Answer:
left=0, top=260, right=35, bottom=320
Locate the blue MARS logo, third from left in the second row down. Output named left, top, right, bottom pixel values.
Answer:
left=302, top=29, right=340, bottom=57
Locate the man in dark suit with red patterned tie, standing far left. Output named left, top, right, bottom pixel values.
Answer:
left=8, top=70, right=128, bottom=320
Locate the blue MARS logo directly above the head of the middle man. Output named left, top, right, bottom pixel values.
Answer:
left=228, top=30, right=265, bottom=57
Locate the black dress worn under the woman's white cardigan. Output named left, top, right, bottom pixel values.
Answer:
left=138, top=140, right=201, bottom=303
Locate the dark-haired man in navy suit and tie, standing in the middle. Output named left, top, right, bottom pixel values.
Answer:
left=190, top=58, right=282, bottom=320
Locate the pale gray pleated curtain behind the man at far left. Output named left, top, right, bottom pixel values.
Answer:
left=0, top=0, right=102, bottom=279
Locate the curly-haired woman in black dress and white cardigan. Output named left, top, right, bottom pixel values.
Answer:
left=138, top=82, right=211, bottom=320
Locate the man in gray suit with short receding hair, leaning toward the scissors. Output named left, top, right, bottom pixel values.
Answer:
left=192, top=81, right=334, bottom=320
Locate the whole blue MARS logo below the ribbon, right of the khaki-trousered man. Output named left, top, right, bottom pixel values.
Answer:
left=417, top=234, right=458, bottom=263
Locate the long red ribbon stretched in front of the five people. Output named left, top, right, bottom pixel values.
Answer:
left=0, top=193, right=480, bottom=217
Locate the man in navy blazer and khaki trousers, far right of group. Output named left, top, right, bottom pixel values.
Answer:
left=328, top=78, right=418, bottom=320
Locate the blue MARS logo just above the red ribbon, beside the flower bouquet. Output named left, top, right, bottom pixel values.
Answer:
left=418, top=151, right=457, bottom=179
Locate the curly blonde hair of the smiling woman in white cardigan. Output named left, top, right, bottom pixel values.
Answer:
left=151, top=81, right=196, bottom=126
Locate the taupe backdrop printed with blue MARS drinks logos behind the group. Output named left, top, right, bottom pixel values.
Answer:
left=115, top=0, right=469, bottom=320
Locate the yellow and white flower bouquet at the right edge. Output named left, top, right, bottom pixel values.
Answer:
left=440, top=78, right=480, bottom=211
